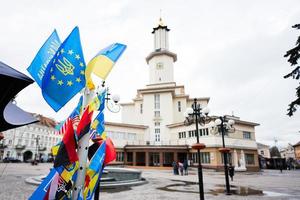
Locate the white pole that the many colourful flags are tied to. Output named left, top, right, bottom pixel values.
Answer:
left=72, top=87, right=94, bottom=200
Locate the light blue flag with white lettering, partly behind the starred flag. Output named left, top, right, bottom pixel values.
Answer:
left=27, top=30, right=61, bottom=87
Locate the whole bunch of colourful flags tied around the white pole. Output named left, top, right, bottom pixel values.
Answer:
left=27, top=27, right=126, bottom=200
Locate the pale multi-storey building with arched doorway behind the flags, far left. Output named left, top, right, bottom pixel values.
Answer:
left=0, top=115, right=62, bottom=162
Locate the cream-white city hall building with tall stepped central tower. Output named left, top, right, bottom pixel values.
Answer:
left=105, top=19, right=259, bottom=171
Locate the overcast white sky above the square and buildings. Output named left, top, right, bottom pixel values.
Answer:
left=0, top=0, right=300, bottom=146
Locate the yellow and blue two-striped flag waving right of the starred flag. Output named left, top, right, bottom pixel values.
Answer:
left=85, top=43, right=126, bottom=89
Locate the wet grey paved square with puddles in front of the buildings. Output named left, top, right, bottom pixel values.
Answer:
left=0, top=163, right=300, bottom=200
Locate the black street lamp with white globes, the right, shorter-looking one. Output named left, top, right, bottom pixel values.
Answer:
left=215, top=116, right=234, bottom=195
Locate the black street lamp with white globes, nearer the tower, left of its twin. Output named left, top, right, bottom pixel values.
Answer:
left=184, top=98, right=209, bottom=200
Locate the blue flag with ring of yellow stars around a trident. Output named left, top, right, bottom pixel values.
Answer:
left=42, top=27, right=86, bottom=112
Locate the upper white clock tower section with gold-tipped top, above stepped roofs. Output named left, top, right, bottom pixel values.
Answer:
left=146, top=18, right=177, bottom=85
